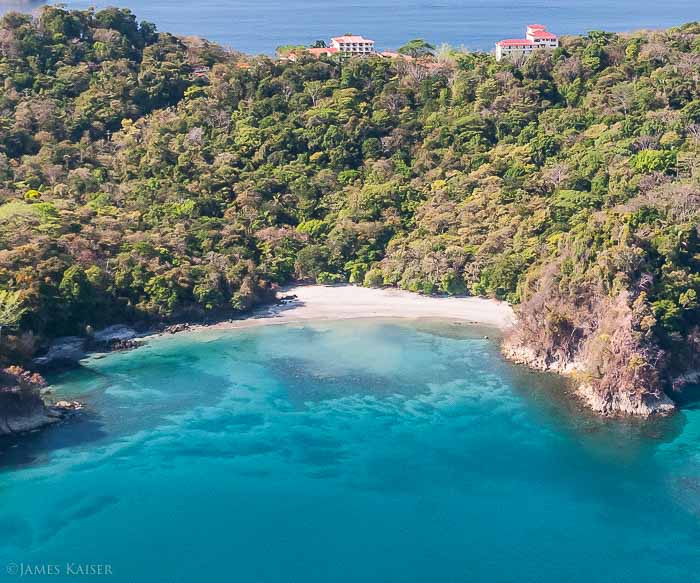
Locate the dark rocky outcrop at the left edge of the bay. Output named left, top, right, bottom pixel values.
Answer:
left=0, top=367, right=82, bottom=435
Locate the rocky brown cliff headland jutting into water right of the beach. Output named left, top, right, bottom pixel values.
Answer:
left=502, top=287, right=675, bottom=417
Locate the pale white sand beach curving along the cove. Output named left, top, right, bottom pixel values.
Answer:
left=205, top=285, right=515, bottom=330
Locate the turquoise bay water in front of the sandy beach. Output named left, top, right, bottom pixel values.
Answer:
left=0, top=321, right=700, bottom=583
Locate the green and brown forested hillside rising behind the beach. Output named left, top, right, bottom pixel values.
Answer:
left=0, top=7, right=700, bottom=412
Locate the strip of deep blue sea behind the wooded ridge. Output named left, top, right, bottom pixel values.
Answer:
left=0, top=0, right=700, bottom=54
